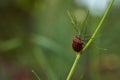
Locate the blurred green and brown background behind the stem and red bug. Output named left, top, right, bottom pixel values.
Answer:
left=0, top=0, right=120, bottom=80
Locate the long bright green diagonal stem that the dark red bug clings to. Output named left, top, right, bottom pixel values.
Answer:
left=66, top=0, right=114, bottom=80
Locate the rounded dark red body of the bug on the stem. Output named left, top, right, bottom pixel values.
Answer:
left=72, top=36, right=83, bottom=52
